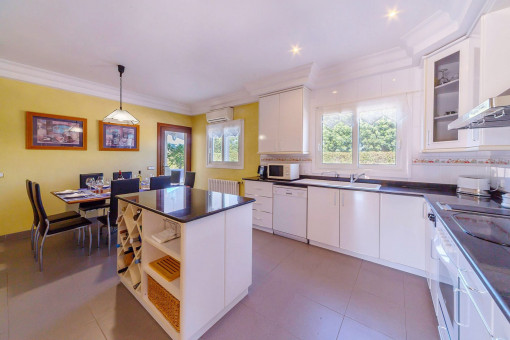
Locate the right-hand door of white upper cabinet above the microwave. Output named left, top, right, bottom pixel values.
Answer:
left=278, top=89, right=303, bottom=152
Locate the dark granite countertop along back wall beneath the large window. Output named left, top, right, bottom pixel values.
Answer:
left=243, top=176, right=456, bottom=196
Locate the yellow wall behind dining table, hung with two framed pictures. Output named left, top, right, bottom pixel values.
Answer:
left=0, top=78, right=191, bottom=235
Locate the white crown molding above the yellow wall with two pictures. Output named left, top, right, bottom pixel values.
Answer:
left=0, top=59, right=191, bottom=115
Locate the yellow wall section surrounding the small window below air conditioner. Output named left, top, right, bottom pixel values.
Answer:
left=191, top=103, right=260, bottom=195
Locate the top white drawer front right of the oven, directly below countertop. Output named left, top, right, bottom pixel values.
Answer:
left=459, top=256, right=494, bottom=333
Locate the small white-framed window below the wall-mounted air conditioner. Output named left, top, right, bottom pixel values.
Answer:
left=206, top=119, right=244, bottom=169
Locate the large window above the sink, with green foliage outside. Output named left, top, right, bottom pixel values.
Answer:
left=316, top=97, right=406, bottom=171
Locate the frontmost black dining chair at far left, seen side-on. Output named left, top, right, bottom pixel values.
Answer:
left=32, top=183, right=92, bottom=271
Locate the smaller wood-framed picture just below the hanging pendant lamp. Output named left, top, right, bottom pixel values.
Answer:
left=99, top=121, right=140, bottom=151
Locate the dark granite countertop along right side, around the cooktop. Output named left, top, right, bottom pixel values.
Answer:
left=425, top=195, right=510, bottom=321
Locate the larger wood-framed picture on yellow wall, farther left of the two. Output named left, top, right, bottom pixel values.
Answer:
left=25, top=112, right=87, bottom=150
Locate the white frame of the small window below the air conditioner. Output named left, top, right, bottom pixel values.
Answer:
left=205, top=119, right=244, bottom=169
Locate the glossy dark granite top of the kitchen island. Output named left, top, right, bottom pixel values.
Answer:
left=117, top=186, right=255, bottom=223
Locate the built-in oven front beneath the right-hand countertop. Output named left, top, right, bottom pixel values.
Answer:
left=433, top=222, right=459, bottom=340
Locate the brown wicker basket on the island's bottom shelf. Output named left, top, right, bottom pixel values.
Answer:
left=147, top=275, right=181, bottom=332
